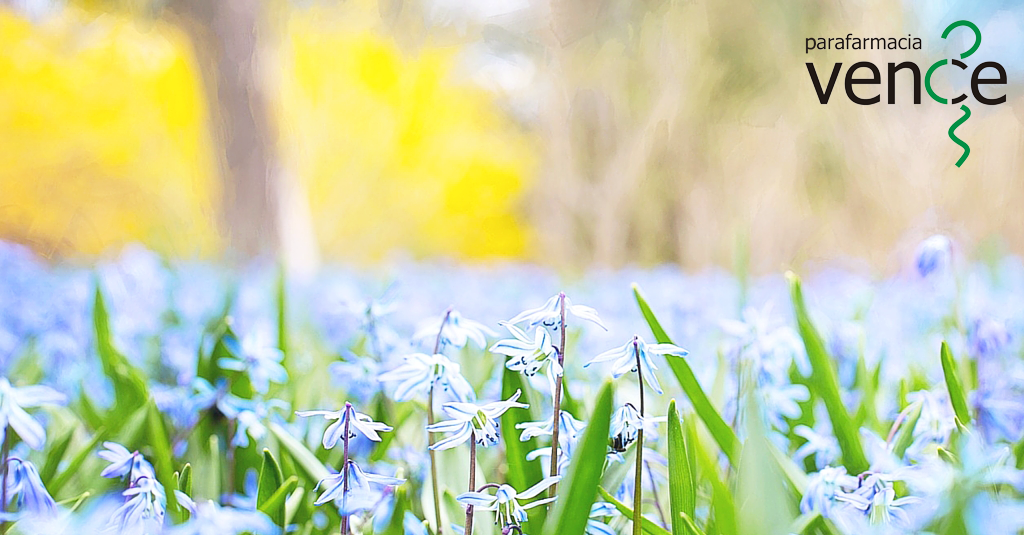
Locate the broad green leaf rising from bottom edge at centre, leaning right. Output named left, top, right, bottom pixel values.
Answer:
left=544, top=381, right=612, bottom=535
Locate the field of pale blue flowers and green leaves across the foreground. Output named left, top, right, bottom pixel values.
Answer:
left=0, top=236, right=1024, bottom=535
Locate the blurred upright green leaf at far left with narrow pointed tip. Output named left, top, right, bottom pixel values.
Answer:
left=92, top=281, right=150, bottom=422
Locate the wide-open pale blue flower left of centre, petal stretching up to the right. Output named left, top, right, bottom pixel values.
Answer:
left=427, top=390, right=529, bottom=450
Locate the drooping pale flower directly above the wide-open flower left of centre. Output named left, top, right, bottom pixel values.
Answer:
left=377, top=353, right=476, bottom=402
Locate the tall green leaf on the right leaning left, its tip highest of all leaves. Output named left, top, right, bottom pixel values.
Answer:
left=785, top=272, right=870, bottom=474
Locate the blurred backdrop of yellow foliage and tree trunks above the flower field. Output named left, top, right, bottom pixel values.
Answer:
left=0, top=0, right=1024, bottom=272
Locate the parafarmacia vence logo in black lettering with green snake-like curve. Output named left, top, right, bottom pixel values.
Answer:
left=805, top=20, right=1007, bottom=167
